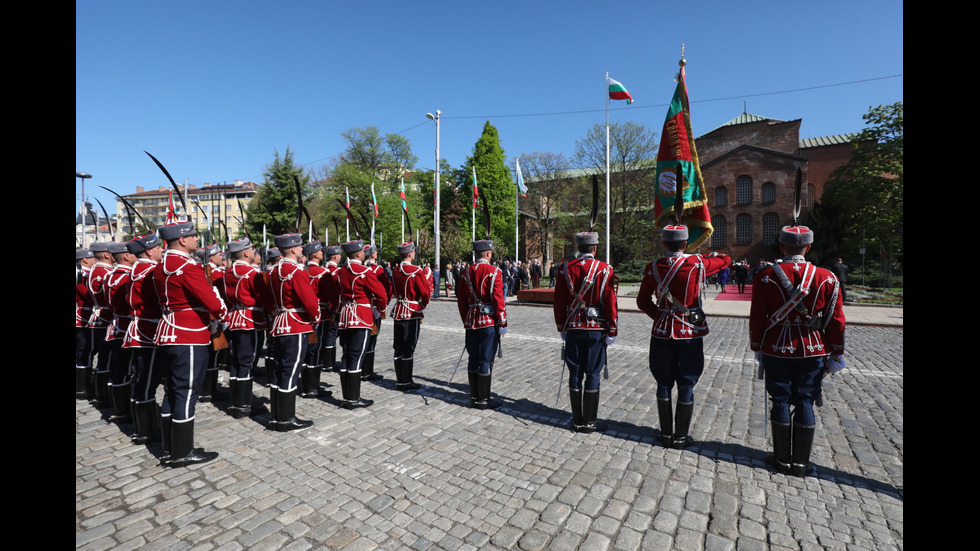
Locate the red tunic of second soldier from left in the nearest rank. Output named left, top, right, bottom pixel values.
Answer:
left=269, top=257, right=320, bottom=337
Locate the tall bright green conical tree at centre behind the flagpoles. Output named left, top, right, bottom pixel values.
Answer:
left=462, top=121, right=517, bottom=256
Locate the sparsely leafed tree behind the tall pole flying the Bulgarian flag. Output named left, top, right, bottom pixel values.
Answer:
left=575, top=122, right=657, bottom=265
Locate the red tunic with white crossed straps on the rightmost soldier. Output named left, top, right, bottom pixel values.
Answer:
left=749, top=256, right=844, bottom=358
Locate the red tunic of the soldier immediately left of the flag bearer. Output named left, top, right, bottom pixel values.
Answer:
left=554, top=255, right=619, bottom=337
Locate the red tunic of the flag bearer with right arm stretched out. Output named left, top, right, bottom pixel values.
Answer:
left=636, top=253, right=732, bottom=339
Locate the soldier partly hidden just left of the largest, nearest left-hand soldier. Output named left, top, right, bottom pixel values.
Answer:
left=123, top=233, right=170, bottom=444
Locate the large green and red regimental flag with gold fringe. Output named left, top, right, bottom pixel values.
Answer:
left=654, top=66, right=714, bottom=252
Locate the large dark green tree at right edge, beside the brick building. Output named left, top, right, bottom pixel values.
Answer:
left=806, top=102, right=905, bottom=265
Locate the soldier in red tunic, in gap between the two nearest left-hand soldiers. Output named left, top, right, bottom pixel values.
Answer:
left=224, top=237, right=275, bottom=419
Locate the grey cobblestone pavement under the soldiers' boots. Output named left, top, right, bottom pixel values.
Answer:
left=75, top=301, right=904, bottom=551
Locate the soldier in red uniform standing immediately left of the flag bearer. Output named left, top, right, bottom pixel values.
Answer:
left=554, top=232, right=619, bottom=433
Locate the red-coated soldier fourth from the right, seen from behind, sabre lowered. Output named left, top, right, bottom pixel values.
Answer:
left=456, top=239, right=507, bottom=409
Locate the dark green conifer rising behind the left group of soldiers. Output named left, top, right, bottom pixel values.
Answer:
left=246, top=147, right=310, bottom=236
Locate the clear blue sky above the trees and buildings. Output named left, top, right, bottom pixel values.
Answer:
left=75, top=0, right=904, bottom=214
